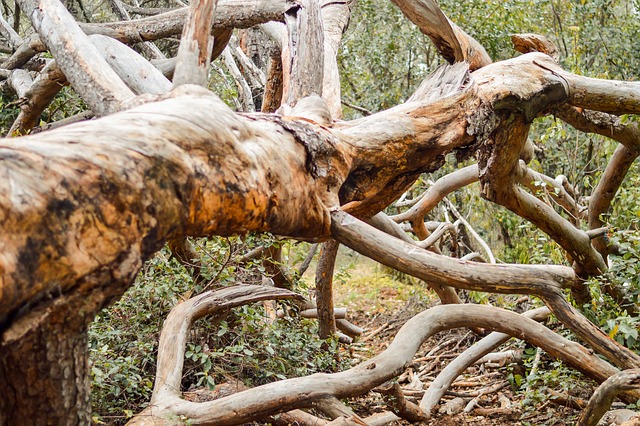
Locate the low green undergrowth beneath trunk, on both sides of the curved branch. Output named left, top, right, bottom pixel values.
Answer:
left=89, top=235, right=348, bottom=424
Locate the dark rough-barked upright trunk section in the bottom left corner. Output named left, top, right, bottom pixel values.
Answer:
left=0, top=298, right=91, bottom=425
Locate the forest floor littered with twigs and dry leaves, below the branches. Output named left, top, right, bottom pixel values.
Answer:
left=334, top=250, right=593, bottom=426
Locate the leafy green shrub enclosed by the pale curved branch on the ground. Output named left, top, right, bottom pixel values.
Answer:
left=183, top=305, right=343, bottom=389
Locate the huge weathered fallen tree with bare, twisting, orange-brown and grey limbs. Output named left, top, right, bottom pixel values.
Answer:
left=0, top=0, right=640, bottom=424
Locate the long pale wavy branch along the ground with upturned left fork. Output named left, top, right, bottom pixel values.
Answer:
left=131, top=304, right=632, bottom=425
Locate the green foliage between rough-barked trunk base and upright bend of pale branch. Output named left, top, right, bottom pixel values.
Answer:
left=89, top=251, right=192, bottom=423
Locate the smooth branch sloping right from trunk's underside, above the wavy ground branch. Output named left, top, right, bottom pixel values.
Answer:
left=331, top=211, right=640, bottom=368
